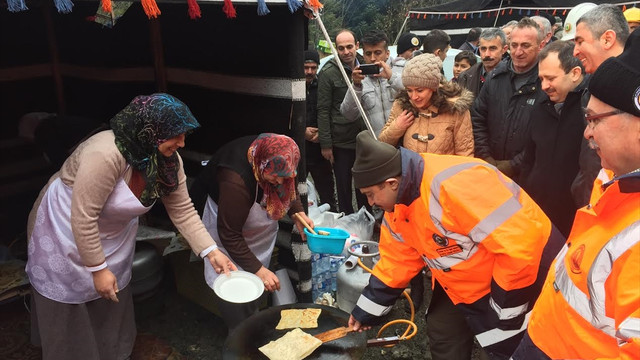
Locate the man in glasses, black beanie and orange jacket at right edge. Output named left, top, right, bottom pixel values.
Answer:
left=513, top=30, right=640, bottom=360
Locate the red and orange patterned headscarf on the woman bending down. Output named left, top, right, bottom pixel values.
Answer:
left=247, top=133, right=300, bottom=220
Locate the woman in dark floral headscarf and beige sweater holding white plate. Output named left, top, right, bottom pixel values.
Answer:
left=26, top=94, right=236, bottom=359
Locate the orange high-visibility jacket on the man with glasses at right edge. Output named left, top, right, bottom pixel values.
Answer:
left=527, top=171, right=640, bottom=359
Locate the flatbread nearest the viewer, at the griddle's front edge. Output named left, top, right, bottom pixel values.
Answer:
left=258, top=328, right=322, bottom=360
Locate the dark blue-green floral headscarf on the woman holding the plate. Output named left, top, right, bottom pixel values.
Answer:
left=111, top=93, right=200, bottom=206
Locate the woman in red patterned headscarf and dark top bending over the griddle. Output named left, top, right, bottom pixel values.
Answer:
left=190, top=133, right=313, bottom=329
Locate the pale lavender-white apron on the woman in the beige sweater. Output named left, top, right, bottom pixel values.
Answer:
left=25, top=178, right=151, bottom=304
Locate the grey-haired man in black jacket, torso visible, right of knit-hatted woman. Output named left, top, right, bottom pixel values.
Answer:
left=471, top=17, right=546, bottom=182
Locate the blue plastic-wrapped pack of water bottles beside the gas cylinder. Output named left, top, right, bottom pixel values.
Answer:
left=311, top=253, right=345, bottom=302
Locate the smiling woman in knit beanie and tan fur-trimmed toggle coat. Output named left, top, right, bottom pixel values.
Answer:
left=378, top=54, right=474, bottom=156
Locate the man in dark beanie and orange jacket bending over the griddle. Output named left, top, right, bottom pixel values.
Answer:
left=349, top=131, right=565, bottom=359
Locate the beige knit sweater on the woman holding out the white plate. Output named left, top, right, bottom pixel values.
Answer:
left=27, top=130, right=214, bottom=266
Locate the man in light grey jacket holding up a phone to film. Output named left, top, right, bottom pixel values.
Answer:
left=340, top=30, right=404, bottom=136
